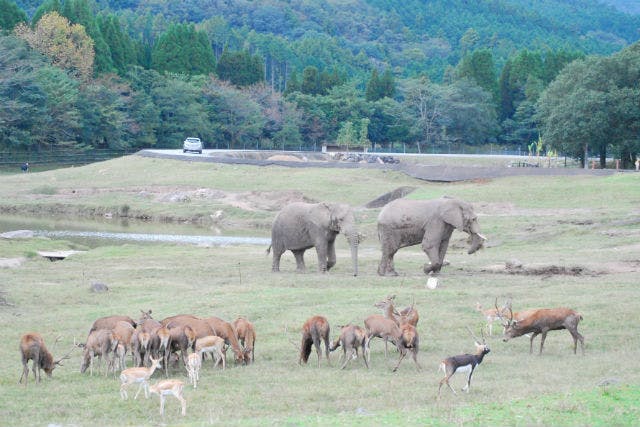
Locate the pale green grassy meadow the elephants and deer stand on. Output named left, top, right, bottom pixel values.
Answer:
left=0, top=156, right=640, bottom=426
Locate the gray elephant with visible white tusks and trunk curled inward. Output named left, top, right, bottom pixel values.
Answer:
left=378, top=197, right=486, bottom=276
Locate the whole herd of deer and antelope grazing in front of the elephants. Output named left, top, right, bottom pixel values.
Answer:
left=19, top=295, right=584, bottom=416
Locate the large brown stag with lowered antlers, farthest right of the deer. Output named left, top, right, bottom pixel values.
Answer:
left=502, top=307, right=584, bottom=355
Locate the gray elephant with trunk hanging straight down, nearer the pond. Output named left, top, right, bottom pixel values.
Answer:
left=267, top=202, right=359, bottom=276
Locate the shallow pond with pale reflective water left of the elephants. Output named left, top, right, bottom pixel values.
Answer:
left=0, top=216, right=271, bottom=248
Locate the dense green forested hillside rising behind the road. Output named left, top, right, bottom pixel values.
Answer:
left=0, top=0, right=640, bottom=169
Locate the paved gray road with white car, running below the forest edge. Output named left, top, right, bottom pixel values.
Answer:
left=137, top=150, right=616, bottom=182
